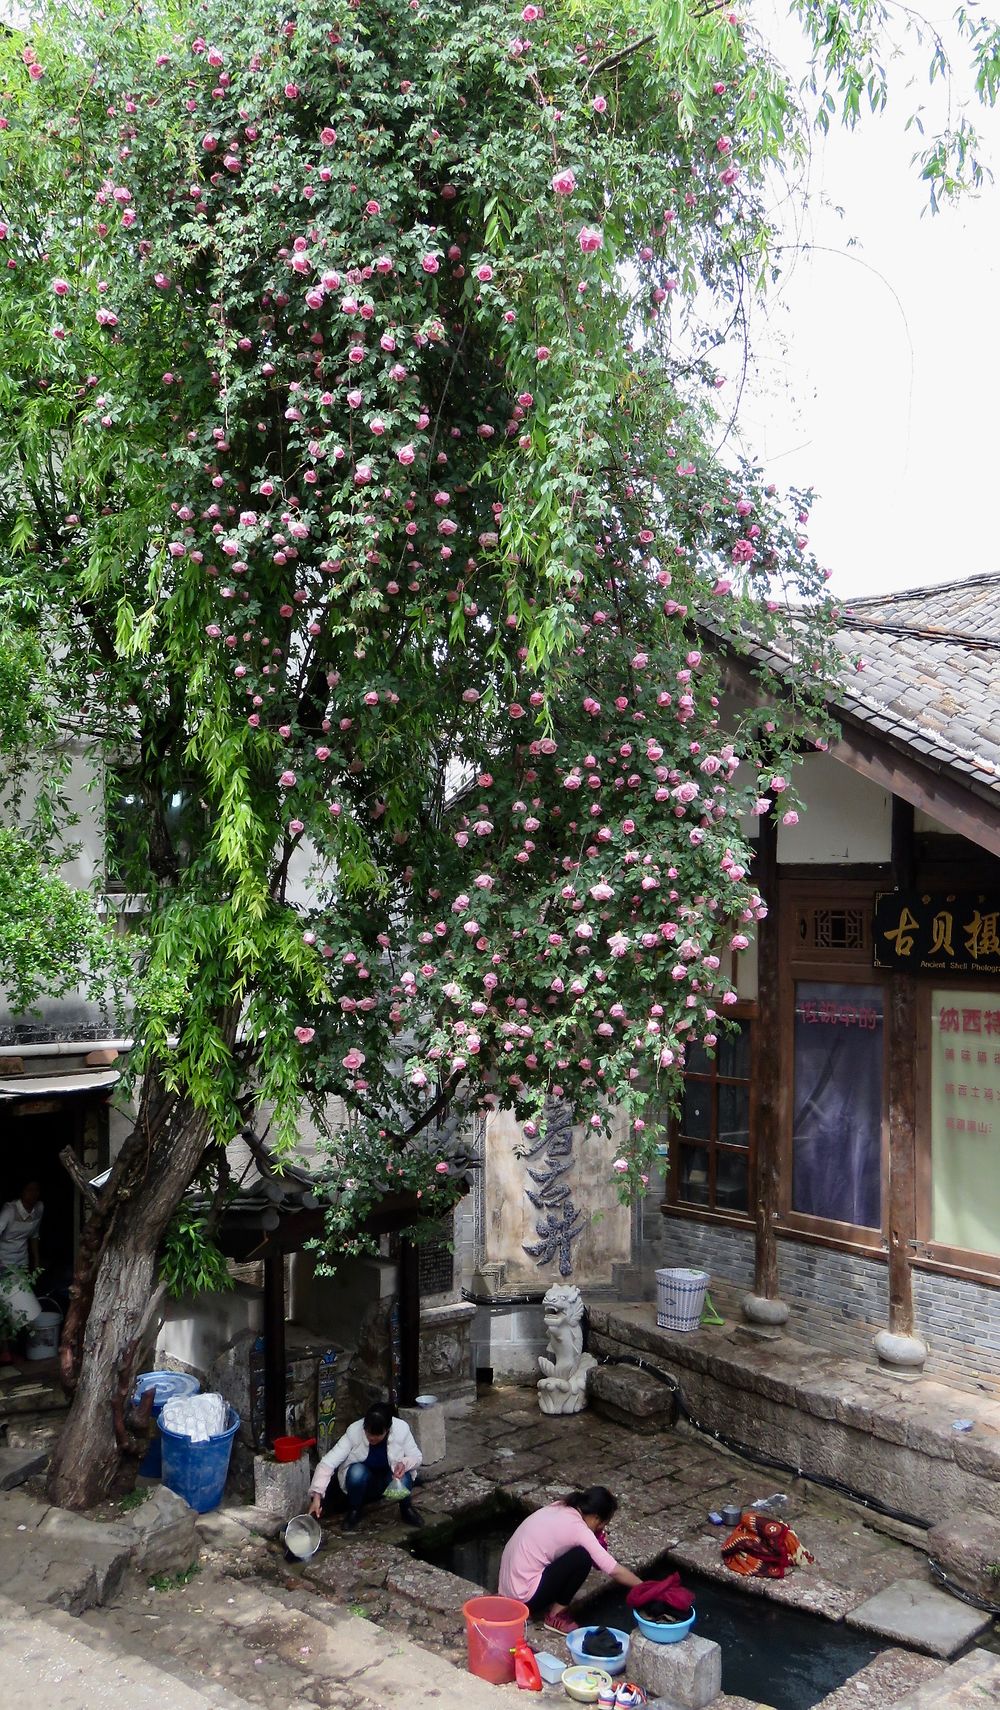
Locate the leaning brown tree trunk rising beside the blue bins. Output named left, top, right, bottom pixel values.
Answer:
left=48, top=1077, right=209, bottom=1508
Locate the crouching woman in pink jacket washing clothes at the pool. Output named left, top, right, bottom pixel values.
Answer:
left=499, top=1484, right=641, bottom=1635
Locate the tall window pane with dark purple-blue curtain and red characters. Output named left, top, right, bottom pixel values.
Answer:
left=791, top=982, right=882, bottom=1228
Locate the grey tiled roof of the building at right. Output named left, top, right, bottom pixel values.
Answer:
left=838, top=571, right=1000, bottom=800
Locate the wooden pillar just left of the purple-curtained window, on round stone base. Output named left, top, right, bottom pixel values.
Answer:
left=750, top=814, right=781, bottom=1300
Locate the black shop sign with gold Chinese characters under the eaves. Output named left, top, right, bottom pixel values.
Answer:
left=872, top=891, right=1000, bottom=980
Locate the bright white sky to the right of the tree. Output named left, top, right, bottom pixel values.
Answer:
left=738, top=0, right=1000, bottom=595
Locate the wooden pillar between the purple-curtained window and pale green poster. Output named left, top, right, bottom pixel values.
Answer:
left=885, top=795, right=916, bottom=1336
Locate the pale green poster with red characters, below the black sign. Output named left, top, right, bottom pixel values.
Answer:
left=930, top=987, right=1000, bottom=1253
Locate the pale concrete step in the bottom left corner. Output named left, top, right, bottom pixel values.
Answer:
left=0, top=1595, right=261, bottom=1710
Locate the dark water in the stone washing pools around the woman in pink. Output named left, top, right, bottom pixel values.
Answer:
left=415, top=1515, right=884, bottom=1710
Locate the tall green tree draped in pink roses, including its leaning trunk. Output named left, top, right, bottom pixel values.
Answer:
left=0, top=0, right=841, bottom=1505
